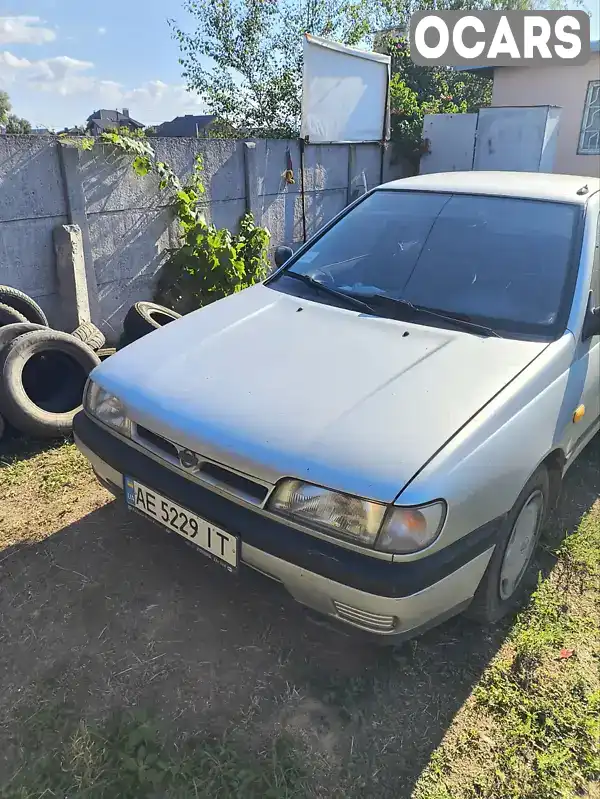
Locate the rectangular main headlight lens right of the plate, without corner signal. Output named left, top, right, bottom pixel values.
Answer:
left=269, top=480, right=386, bottom=546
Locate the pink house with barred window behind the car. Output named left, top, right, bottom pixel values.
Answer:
left=461, top=41, right=600, bottom=177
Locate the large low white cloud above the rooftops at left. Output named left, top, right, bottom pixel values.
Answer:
left=0, top=50, right=204, bottom=128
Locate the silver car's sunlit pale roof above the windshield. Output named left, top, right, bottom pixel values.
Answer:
left=380, top=171, right=600, bottom=205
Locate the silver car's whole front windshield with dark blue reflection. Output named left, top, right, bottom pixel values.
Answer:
left=277, top=190, right=580, bottom=335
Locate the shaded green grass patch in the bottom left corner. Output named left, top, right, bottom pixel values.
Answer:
left=0, top=708, right=306, bottom=799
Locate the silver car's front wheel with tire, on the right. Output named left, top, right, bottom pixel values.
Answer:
left=465, top=466, right=551, bottom=624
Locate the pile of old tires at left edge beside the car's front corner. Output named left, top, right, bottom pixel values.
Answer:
left=0, top=286, right=105, bottom=439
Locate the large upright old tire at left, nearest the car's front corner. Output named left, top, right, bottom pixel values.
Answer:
left=0, top=329, right=100, bottom=438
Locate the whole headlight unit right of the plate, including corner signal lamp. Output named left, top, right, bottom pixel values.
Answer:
left=269, top=480, right=446, bottom=555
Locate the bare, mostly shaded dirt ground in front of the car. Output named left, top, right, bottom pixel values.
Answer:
left=0, top=442, right=600, bottom=799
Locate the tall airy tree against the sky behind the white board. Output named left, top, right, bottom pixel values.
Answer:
left=171, top=0, right=390, bottom=137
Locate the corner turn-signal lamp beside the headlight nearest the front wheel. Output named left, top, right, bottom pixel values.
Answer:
left=377, top=500, right=446, bottom=555
